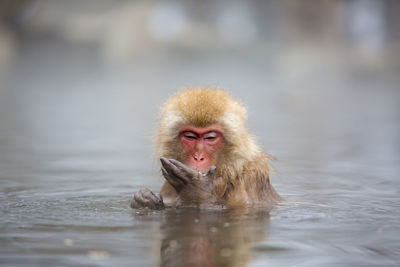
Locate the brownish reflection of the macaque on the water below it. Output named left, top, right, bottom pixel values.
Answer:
left=135, top=208, right=269, bottom=266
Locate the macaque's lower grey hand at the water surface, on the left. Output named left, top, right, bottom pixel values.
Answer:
left=130, top=188, right=164, bottom=210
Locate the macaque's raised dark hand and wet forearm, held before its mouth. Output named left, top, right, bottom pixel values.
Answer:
left=160, top=158, right=217, bottom=204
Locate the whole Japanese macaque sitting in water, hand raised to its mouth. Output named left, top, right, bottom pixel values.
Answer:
left=131, top=88, right=280, bottom=209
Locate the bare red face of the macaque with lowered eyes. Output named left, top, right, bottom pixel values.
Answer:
left=179, top=125, right=224, bottom=172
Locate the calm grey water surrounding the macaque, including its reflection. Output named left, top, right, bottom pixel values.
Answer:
left=0, top=38, right=400, bottom=266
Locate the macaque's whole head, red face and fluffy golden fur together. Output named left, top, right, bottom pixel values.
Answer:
left=156, top=88, right=260, bottom=175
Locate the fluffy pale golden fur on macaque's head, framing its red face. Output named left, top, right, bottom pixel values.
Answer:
left=156, top=88, right=268, bottom=195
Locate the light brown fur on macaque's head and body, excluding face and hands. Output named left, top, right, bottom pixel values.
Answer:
left=156, top=88, right=279, bottom=207
